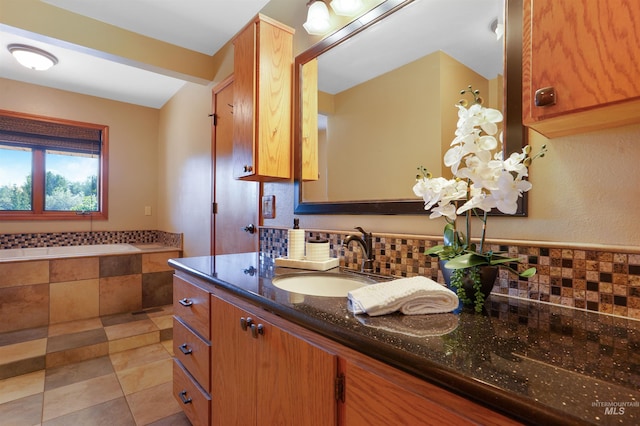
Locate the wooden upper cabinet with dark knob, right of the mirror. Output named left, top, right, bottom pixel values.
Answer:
left=523, top=0, right=640, bottom=137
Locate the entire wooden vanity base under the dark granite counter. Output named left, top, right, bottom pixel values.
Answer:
left=174, top=271, right=519, bottom=426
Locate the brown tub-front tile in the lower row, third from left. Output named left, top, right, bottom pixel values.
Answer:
left=100, top=274, right=142, bottom=316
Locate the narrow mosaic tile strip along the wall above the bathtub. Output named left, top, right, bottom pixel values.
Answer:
left=0, top=230, right=182, bottom=250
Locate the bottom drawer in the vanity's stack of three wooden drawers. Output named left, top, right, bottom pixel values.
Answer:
left=173, top=360, right=211, bottom=426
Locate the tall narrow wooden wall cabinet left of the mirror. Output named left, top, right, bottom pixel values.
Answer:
left=233, top=15, right=294, bottom=181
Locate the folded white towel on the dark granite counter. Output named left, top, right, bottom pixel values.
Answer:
left=348, top=276, right=459, bottom=316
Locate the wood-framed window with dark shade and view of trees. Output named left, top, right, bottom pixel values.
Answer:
left=0, top=110, right=108, bottom=220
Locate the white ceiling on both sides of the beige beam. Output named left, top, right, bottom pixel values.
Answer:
left=0, top=0, right=270, bottom=108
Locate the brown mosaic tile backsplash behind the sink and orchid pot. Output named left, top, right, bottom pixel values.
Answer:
left=260, top=228, right=640, bottom=320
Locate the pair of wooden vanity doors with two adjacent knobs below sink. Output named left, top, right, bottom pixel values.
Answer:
left=211, top=295, right=337, bottom=426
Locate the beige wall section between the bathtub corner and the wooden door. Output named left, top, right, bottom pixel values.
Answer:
left=157, top=83, right=212, bottom=256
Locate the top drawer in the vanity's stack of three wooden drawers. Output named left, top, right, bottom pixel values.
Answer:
left=173, top=275, right=211, bottom=340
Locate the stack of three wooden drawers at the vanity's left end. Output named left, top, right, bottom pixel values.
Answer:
left=173, top=275, right=211, bottom=426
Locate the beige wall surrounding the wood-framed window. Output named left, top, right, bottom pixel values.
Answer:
left=0, top=78, right=159, bottom=233
